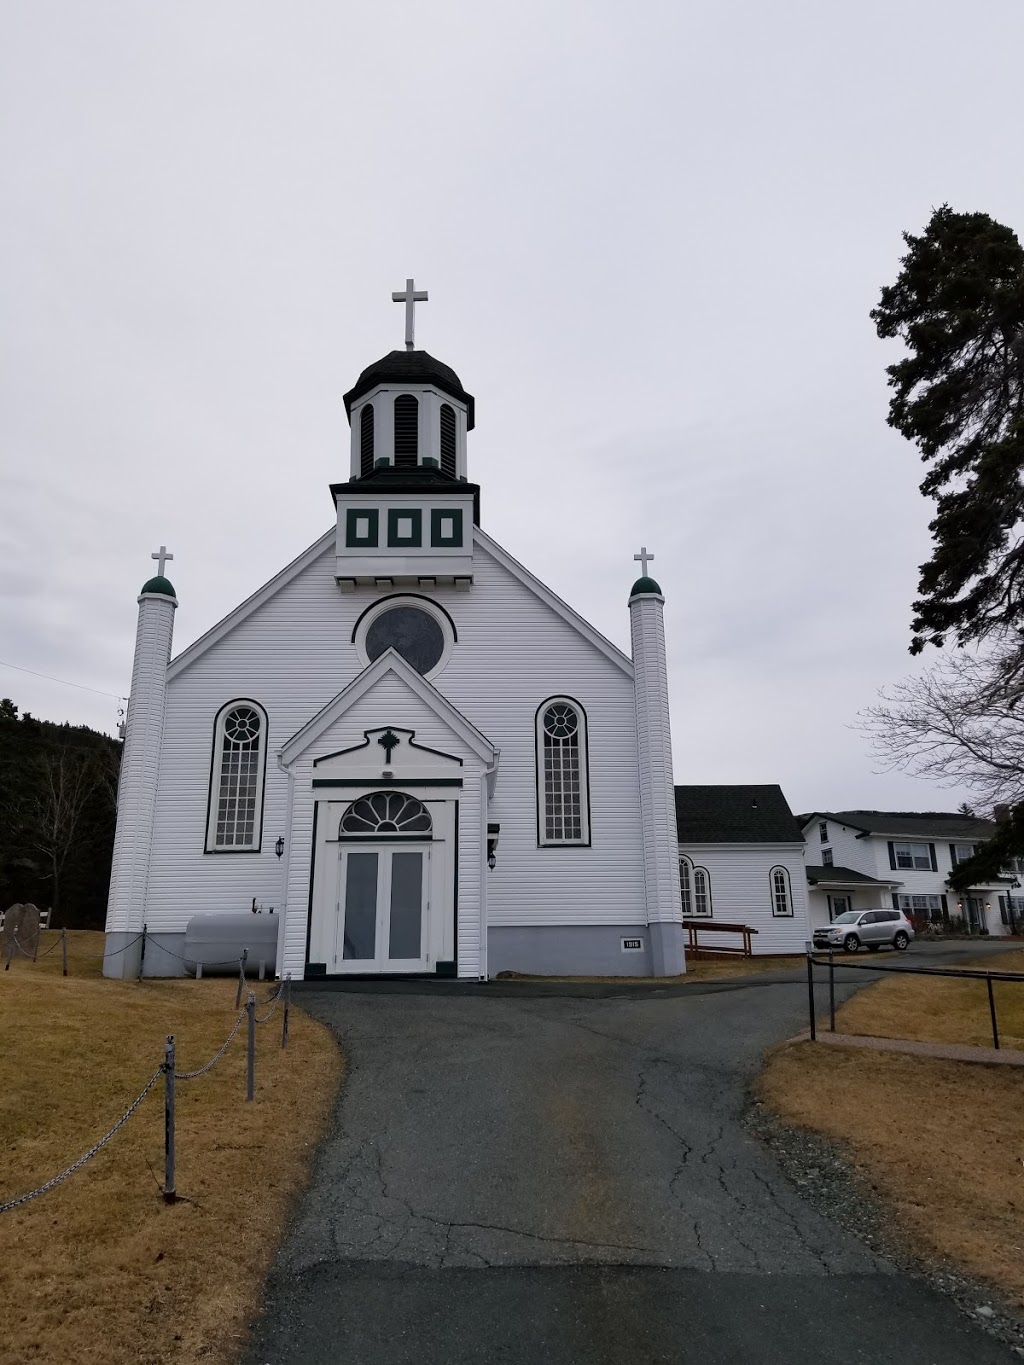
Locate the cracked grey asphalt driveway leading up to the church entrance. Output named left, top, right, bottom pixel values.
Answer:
left=247, top=981, right=1016, bottom=1365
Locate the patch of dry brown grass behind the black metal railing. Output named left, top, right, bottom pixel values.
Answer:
left=835, top=953, right=1024, bottom=1047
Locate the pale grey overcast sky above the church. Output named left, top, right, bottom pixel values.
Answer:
left=0, top=0, right=1024, bottom=809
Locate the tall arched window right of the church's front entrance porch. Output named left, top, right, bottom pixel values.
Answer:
left=537, top=696, right=590, bottom=844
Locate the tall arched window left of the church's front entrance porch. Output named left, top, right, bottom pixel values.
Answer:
left=206, top=700, right=266, bottom=853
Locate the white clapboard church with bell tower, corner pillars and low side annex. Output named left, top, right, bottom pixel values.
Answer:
left=104, top=281, right=810, bottom=980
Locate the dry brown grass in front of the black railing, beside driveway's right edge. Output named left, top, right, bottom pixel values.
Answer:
left=760, top=1043, right=1024, bottom=1304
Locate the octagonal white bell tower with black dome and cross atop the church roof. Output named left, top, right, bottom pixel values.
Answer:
left=330, top=280, right=479, bottom=592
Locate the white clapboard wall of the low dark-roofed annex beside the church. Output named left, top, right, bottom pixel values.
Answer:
left=680, top=844, right=811, bottom=954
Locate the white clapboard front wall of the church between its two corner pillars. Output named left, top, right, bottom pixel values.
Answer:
left=146, top=526, right=644, bottom=971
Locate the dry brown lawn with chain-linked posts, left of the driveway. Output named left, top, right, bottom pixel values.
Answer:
left=0, top=932, right=343, bottom=1365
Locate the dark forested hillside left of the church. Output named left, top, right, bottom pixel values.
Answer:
left=0, top=698, right=122, bottom=928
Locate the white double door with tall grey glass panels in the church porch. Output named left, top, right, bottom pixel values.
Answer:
left=333, top=844, right=430, bottom=972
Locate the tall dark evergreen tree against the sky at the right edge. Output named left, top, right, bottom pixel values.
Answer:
left=871, top=205, right=1024, bottom=660
